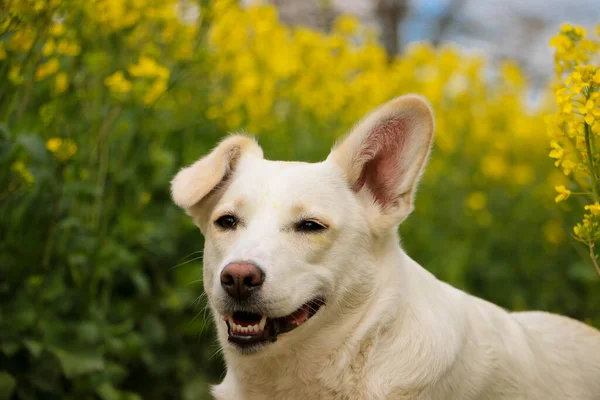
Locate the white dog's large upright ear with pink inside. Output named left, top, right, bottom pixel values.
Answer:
left=328, top=95, right=434, bottom=223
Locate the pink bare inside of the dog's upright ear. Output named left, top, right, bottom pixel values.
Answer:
left=354, top=117, right=408, bottom=206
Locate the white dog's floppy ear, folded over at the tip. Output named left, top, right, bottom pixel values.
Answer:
left=171, top=135, right=263, bottom=210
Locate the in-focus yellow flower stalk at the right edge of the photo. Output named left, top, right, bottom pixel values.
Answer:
left=546, top=25, right=600, bottom=274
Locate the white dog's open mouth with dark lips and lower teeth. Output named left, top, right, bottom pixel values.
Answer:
left=224, top=298, right=325, bottom=348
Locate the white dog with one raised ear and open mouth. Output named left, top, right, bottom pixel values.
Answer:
left=172, top=96, right=600, bottom=400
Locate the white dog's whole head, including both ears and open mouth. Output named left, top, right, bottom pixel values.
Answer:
left=172, top=96, right=433, bottom=354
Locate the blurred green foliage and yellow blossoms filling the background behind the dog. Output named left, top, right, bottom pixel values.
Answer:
left=0, top=0, right=600, bottom=400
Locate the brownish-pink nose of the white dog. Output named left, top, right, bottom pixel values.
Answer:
left=221, top=263, right=265, bottom=301
